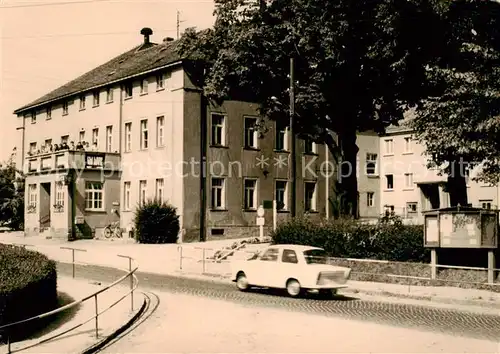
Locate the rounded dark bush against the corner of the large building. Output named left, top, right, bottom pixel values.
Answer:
left=134, top=200, right=180, bottom=244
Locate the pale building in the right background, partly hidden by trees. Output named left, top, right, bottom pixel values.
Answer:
left=380, top=122, right=499, bottom=223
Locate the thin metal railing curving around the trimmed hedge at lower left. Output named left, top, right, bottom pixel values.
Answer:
left=0, top=243, right=139, bottom=354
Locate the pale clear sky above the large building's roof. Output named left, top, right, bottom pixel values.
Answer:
left=0, top=0, right=214, bottom=161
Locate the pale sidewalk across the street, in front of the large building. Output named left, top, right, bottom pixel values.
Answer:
left=0, top=234, right=500, bottom=309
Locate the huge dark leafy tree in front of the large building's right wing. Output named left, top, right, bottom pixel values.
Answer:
left=178, top=0, right=452, bottom=216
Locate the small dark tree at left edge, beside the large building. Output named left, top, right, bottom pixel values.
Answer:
left=0, top=153, right=24, bottom=230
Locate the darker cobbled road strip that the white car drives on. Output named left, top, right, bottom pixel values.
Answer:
left=58, top=264, right=500, bottom=341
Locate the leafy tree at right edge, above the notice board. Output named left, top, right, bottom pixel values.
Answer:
left=412, top=0, right=500, bottom=206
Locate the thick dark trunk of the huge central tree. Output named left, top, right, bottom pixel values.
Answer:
left=338, top=130, right=359, bottom=219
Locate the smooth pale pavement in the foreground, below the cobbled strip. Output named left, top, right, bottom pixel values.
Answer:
left=100, top=292, right=500, bottom=353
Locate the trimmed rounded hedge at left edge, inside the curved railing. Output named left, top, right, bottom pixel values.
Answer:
left=0, top=244, right=58, bottom=341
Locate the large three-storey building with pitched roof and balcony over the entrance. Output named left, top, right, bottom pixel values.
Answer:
left=14, top=29, right=338, bottom=240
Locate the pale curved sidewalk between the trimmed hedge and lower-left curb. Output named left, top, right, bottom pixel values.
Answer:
left=0, top=276, right=144, bottom=353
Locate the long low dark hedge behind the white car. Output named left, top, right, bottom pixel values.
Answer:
left=271, top=218, right=429, bottom=262
